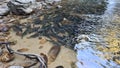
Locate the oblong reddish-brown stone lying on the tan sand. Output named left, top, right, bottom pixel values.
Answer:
left=48, top=46, right=60, bottom=64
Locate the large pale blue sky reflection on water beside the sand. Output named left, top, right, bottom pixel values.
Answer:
left=74, top=34, right=120, bottom=68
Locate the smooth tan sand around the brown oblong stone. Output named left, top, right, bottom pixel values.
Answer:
left=0, top=32, right=76, bottom=68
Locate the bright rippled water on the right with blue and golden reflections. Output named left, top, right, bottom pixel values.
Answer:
left=74, top=0, right=120, bottom=68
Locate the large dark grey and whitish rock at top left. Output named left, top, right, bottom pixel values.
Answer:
left=7, top=0, right=42, bottom=15
